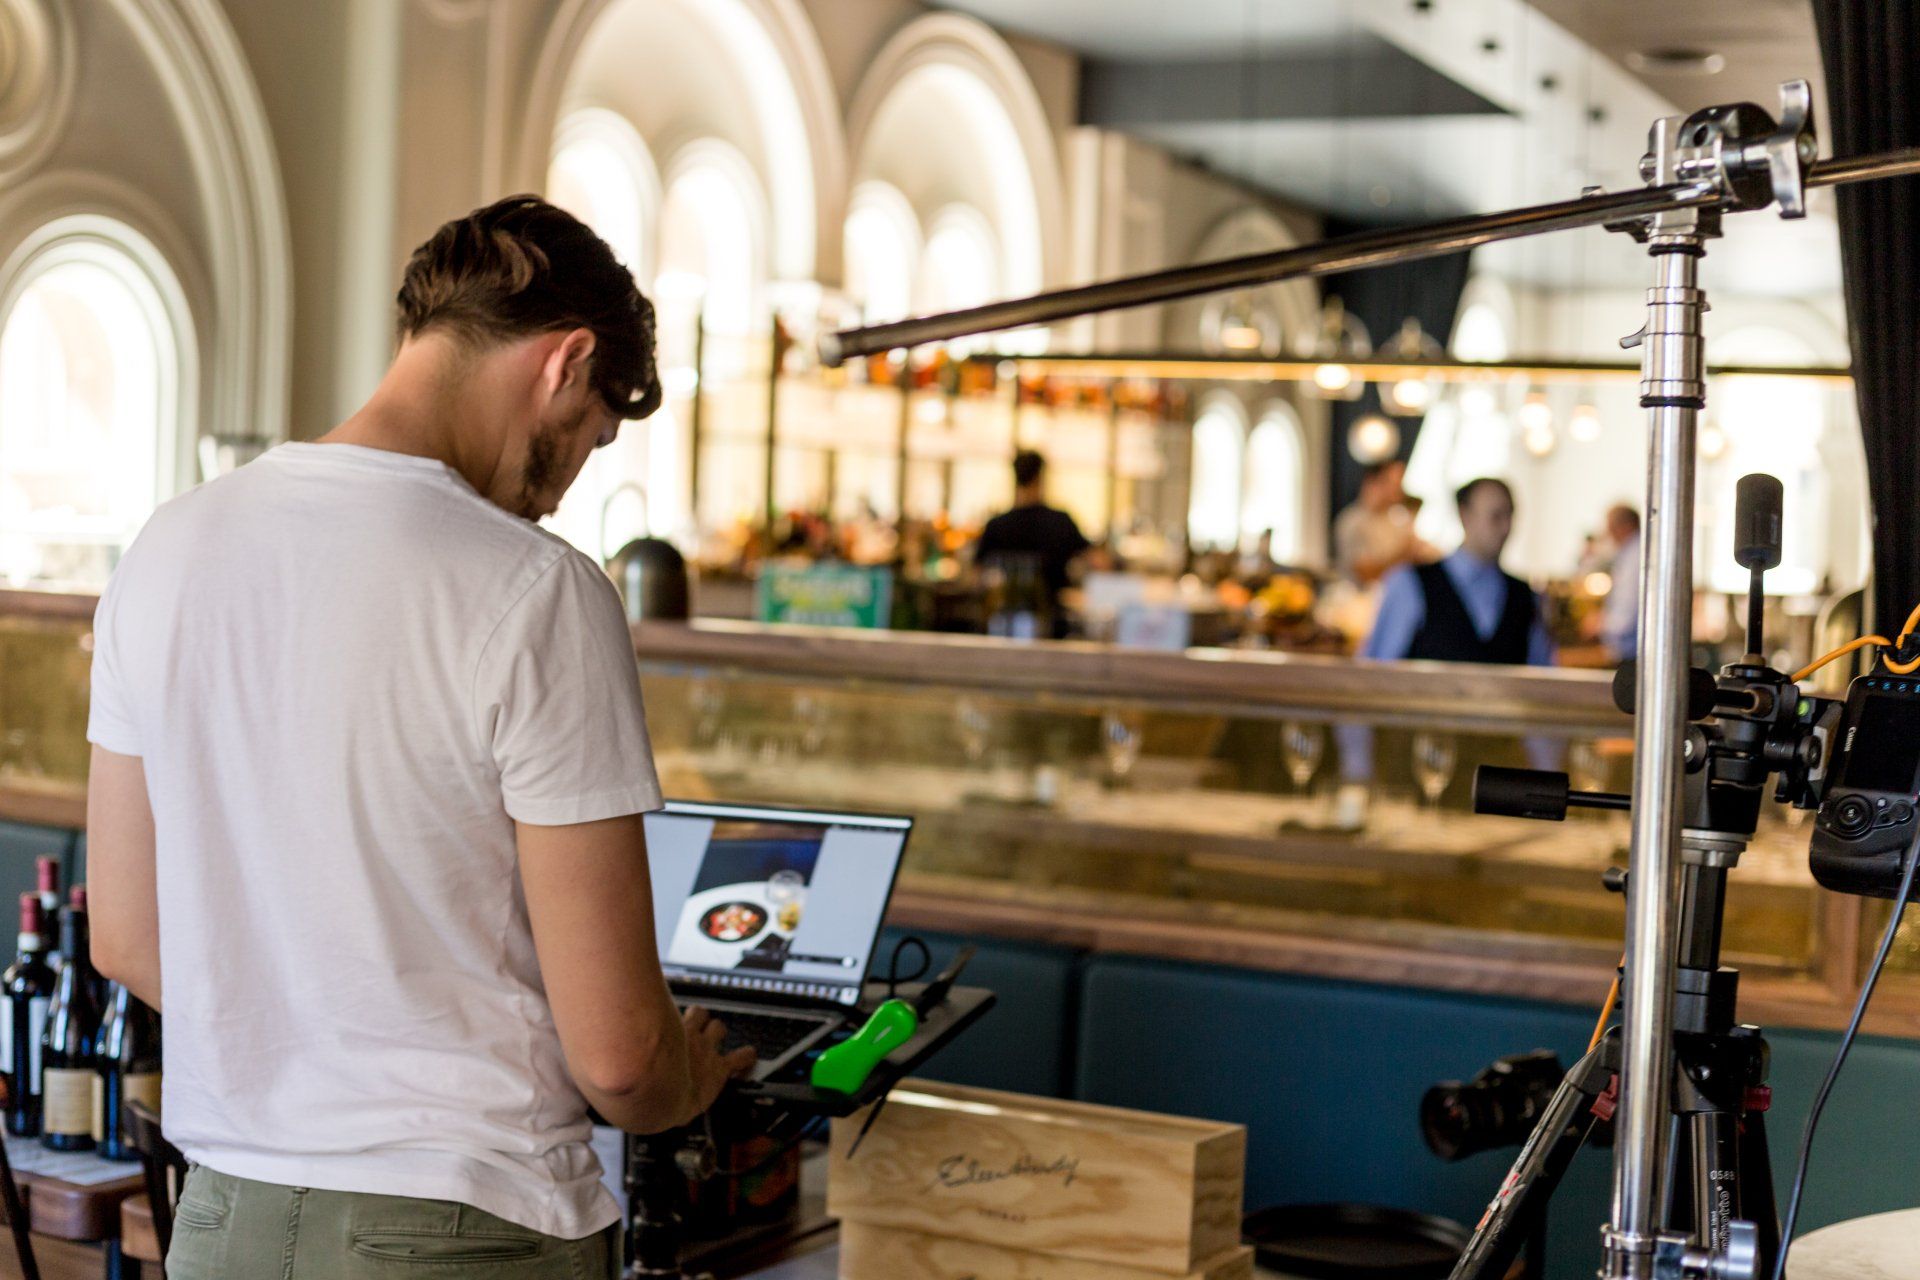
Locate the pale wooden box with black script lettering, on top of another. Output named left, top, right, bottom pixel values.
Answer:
left=828, top=1080, right=1246, bottom=1276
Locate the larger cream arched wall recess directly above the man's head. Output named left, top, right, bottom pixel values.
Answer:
left=526, top=0, right=847, bottom=282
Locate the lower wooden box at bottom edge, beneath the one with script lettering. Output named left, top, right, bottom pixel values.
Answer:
left=839, top=1219, right=1254, bottom=1280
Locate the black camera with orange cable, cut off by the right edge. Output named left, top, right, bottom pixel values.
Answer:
left=1809, top=666, right=1920, bottom=898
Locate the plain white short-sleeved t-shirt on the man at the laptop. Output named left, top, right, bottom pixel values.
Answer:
left=88, top=443, right=660, bottom=1238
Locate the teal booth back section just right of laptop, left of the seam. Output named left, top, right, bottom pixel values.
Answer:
left=874, top=929, right=1083, bottom=1098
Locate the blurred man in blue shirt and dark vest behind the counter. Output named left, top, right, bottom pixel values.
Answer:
left=1359, top=480, right=1553, bottom=666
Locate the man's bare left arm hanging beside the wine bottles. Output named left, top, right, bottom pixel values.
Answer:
left=86, top=747, right=159, bottom=1009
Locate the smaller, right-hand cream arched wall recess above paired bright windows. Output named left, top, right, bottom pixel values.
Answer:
left=847, top=13, right=1066, bottom=307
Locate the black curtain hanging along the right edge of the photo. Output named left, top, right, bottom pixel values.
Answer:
left=1812, top=0, right=1920, bottom=628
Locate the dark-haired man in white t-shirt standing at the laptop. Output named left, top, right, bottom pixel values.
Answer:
left=88, top=196, right=751, bottom=1280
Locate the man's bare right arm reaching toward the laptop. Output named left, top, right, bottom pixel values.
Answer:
left=515, top=814, right=753, bottom=1134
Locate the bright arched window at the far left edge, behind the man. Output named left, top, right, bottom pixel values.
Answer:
left=0, top=217, right=194, bottom=585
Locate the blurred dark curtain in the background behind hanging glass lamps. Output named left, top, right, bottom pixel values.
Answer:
left=1321, top=219, right=1473, bottom=529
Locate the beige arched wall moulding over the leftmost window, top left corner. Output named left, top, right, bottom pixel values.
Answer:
left=0, top=0, right=292, bottom=452
